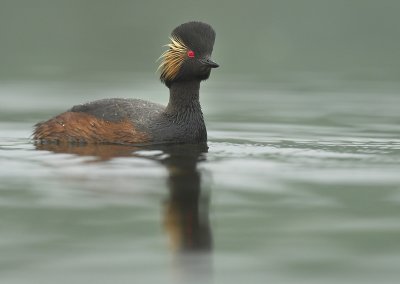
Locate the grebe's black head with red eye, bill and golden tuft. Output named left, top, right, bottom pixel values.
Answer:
left=159, top=22, right=218, bottom=87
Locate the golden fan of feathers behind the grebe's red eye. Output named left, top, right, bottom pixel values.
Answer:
left=157, top=36, right=189, bottom=82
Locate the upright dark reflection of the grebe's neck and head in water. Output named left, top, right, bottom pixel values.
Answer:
left=162, top=145, right=211, bottom=252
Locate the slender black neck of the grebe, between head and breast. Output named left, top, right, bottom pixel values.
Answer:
left=165, top=80, right=202, bottom=115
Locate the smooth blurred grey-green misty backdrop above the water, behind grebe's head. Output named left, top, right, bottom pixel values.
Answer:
left=0, top=0, right=400, bottom=82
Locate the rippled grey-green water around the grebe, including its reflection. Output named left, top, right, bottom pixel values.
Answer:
left=0, top=78, right=400, bottom=284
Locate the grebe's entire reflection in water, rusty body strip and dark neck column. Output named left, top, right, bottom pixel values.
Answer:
left=36, top=144, right=212, bottom=255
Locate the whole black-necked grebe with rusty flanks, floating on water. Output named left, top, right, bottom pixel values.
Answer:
left=33, top=22, right=218, bottom=144
